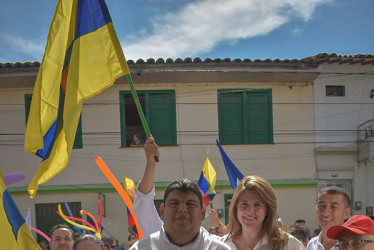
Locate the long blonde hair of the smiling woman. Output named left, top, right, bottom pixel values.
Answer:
left=227, top=175, right=288, bottom=250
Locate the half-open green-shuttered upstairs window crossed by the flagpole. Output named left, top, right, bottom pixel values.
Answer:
left=120, top=90, right=177, bottom=147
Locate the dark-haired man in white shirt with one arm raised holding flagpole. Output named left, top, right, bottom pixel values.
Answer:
left=130, top=138, right=230, bottom=250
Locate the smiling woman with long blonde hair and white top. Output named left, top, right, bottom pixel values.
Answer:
left=224, top=175, right=305, bottom=250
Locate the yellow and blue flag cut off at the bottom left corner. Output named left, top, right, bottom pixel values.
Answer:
left=0, top=169, right=41, bottom=250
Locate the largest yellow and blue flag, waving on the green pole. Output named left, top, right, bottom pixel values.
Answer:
left=24, top=0, right=130, bottom=198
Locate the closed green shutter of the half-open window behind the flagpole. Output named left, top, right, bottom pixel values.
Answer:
left=146, top=91, right=177, bottom=145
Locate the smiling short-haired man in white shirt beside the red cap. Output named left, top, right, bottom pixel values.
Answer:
left=307, top=186, right=351, bottom=250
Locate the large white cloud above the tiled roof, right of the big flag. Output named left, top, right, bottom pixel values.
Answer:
left=123, top=0, right=331, bottom=60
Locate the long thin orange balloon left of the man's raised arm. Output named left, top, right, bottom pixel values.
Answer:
left=95, top=156, right=144, bottom=239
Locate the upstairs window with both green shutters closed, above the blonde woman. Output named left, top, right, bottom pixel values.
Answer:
left=218, top=89, right=273, bottom=144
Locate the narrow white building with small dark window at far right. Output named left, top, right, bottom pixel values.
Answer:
left=312, top=54, right=374, bottom=216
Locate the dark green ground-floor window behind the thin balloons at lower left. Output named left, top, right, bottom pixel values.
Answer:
left=35, top=202, right=81, bottom=241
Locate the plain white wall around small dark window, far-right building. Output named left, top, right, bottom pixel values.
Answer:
left=314, top=63, right=374, bottom=217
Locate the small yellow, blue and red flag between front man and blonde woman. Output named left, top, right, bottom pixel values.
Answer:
left=197, top=156, right=217, bottom=206
